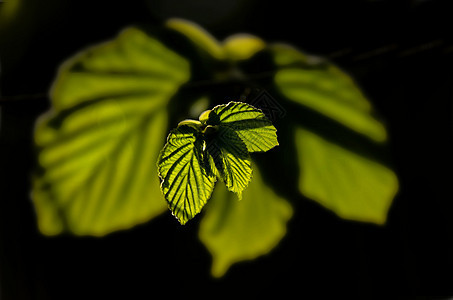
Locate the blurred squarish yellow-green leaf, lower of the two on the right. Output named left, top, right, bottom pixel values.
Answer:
left=295, top=128, right=398, bottom=224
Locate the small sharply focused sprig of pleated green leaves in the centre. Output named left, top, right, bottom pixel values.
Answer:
left=157, top=102, right=278, bottom=220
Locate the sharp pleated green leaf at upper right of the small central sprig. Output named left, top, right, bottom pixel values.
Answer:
left=208, top=101, right=278, bottom=152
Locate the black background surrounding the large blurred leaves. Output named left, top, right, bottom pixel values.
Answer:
left=0, top=0, right=453, bottom=300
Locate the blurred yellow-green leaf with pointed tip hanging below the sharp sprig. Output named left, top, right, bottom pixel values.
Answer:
left=199, top=165, right=292, bottom=277
